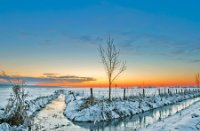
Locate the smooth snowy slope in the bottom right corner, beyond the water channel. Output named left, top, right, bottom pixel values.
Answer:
left=141, top=102, right=200, bottom=131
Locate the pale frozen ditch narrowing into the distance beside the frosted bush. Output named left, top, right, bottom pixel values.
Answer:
left=31, top=94, right=78, bottom=131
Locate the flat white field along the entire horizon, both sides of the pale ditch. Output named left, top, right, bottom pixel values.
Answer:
left=0, top=85, right=197, bottom=109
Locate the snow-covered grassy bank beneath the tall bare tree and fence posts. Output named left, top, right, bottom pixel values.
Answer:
left=64, top=91, right=200, bottom=123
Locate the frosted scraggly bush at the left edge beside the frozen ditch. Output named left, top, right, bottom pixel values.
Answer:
left=2, top=72, right=30, bottom=126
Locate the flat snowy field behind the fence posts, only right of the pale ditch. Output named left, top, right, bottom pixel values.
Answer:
left=68, top=87, right=197, bottom=98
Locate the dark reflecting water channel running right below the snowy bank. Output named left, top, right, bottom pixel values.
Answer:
left=70, top=98, right=200, bottom=131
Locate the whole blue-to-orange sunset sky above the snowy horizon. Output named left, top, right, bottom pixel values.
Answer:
left=0, top=0, right=200, bottom=87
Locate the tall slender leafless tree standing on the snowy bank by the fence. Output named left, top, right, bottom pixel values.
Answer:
left=99, top=37, right=126, bottom=101
